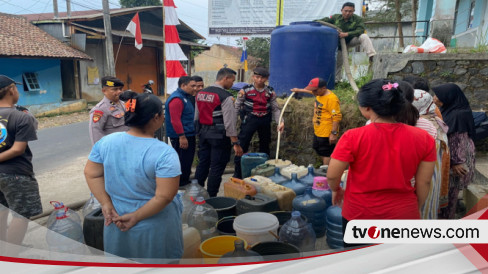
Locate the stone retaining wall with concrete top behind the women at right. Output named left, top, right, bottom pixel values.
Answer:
left=373, top=53, right=488, bottom=111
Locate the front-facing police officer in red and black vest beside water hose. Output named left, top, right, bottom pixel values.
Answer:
left=234, top=67, right=285, bottom=178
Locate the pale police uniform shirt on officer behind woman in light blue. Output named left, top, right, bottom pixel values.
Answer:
left=90, top=96, right=129, bottom=145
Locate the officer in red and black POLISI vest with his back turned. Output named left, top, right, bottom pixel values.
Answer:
left=195, top=68, right=242, bottom=197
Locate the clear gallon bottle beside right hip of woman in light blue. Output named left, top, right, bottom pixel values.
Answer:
left=188, top=197, right=219, bottom=242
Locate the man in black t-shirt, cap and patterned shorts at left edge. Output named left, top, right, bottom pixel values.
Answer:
left=0, top=75, right=42, bottom=255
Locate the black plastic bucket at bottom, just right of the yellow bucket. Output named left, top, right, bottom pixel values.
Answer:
left=251, top=242, right=300, bottom=260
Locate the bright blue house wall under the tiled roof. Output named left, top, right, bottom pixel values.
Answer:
left=0, top=58, right=63, bottom=106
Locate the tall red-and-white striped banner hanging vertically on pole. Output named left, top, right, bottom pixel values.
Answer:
left=163, top=0, right=188, bottom=94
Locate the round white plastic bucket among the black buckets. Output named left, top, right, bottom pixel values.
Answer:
left=233, top=212, right=279, bottom=245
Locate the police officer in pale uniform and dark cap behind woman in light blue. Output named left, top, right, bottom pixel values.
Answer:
left=89, top=76, right=129, bottom=145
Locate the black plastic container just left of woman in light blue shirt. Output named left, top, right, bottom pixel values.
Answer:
left=83, top=208, right=105, bottom=251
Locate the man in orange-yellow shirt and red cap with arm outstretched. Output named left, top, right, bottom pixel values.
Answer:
left=291, top=78, right=342, bottom=165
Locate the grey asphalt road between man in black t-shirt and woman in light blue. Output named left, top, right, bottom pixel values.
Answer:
left=29, top=121, right=92, bottom=174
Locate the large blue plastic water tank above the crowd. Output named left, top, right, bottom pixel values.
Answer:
left=269, top=22, right=339, bottom=95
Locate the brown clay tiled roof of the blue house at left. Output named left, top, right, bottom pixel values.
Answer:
left=0, top=13, right=92, bottom=60
